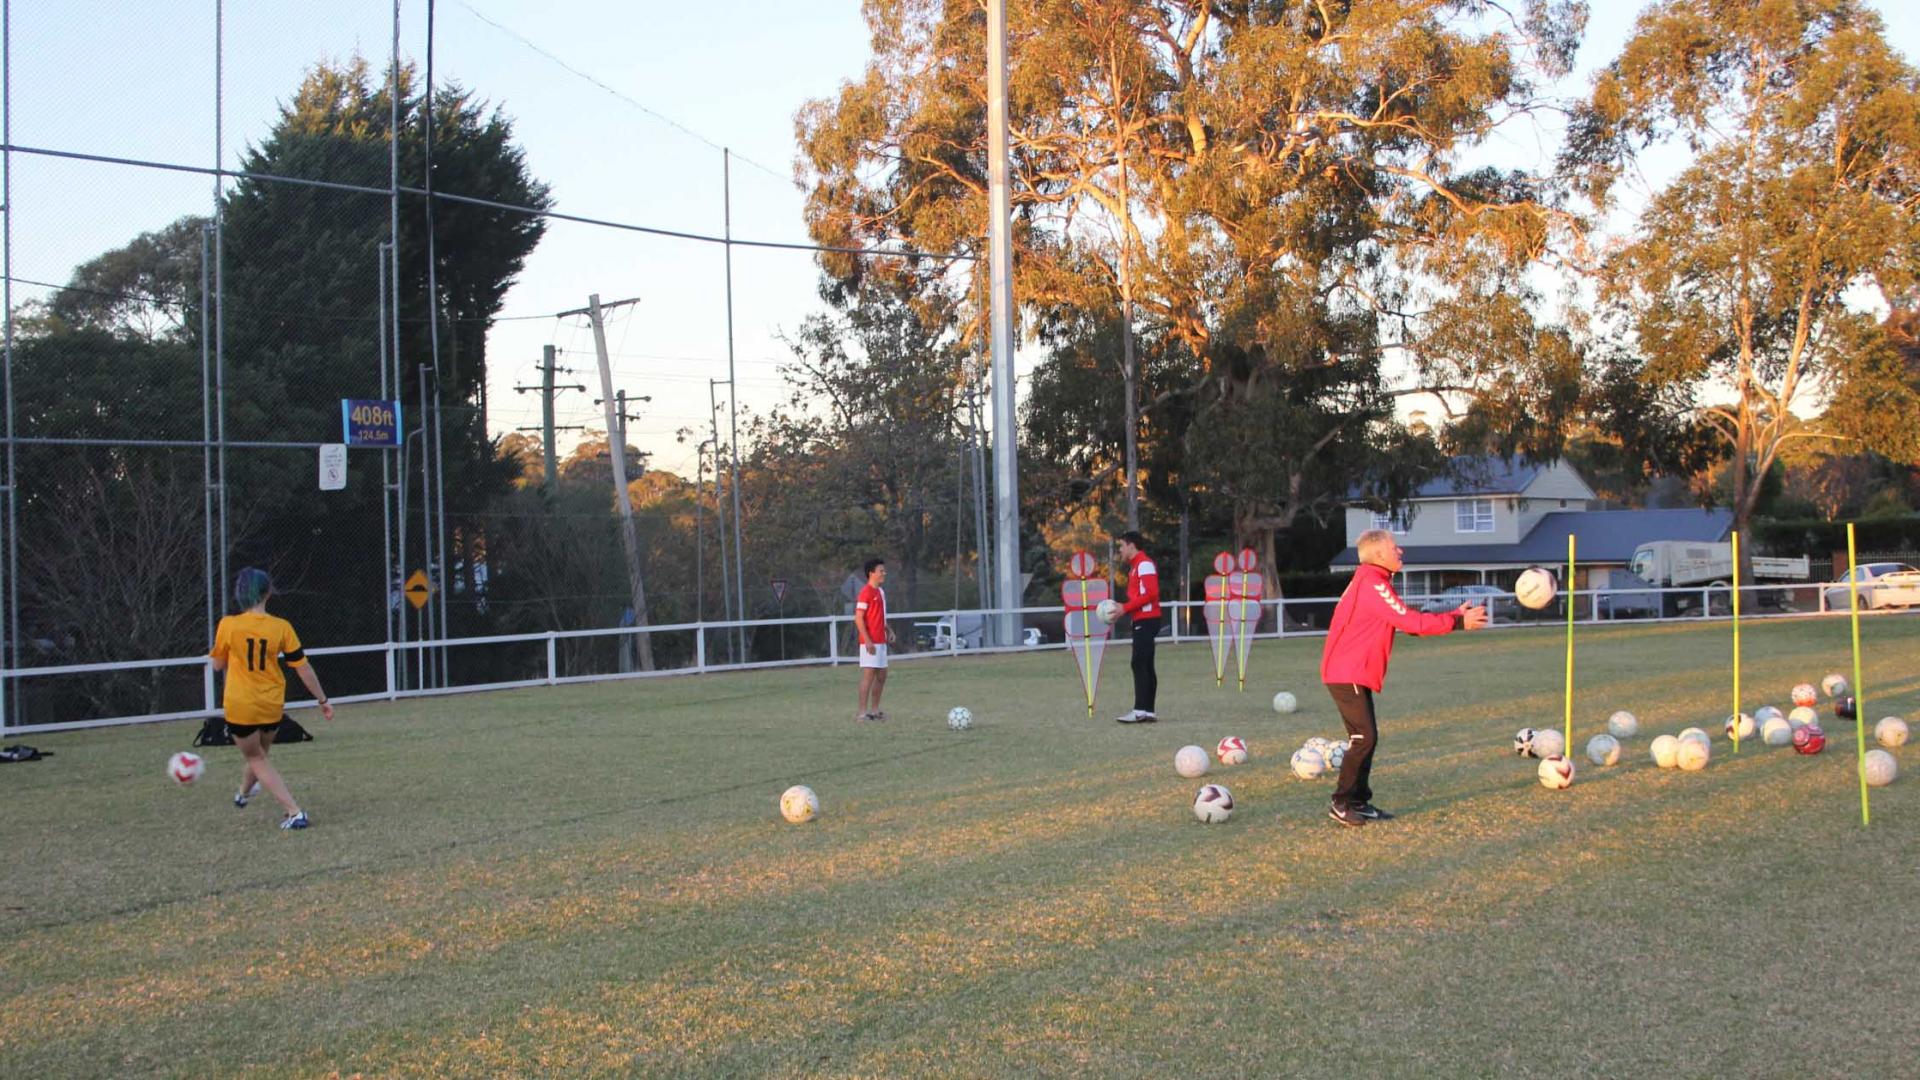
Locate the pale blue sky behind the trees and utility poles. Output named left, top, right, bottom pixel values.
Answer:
left=8, top=0, right=1920, bottom=477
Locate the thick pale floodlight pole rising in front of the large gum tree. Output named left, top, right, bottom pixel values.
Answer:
left=987, top=0, right=1020, bottom=646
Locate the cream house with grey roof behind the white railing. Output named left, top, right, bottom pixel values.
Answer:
left=1331, top=449, right=1734, bottom=596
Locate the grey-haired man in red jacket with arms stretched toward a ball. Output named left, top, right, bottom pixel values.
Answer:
left=1321, top=528, right=1486, bottom=824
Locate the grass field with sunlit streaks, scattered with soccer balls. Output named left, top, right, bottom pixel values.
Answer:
left=0, top=617, right=1920, bottom=1078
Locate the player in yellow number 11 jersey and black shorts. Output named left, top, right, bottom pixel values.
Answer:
left=209, top=567, right=334, bottom=828
